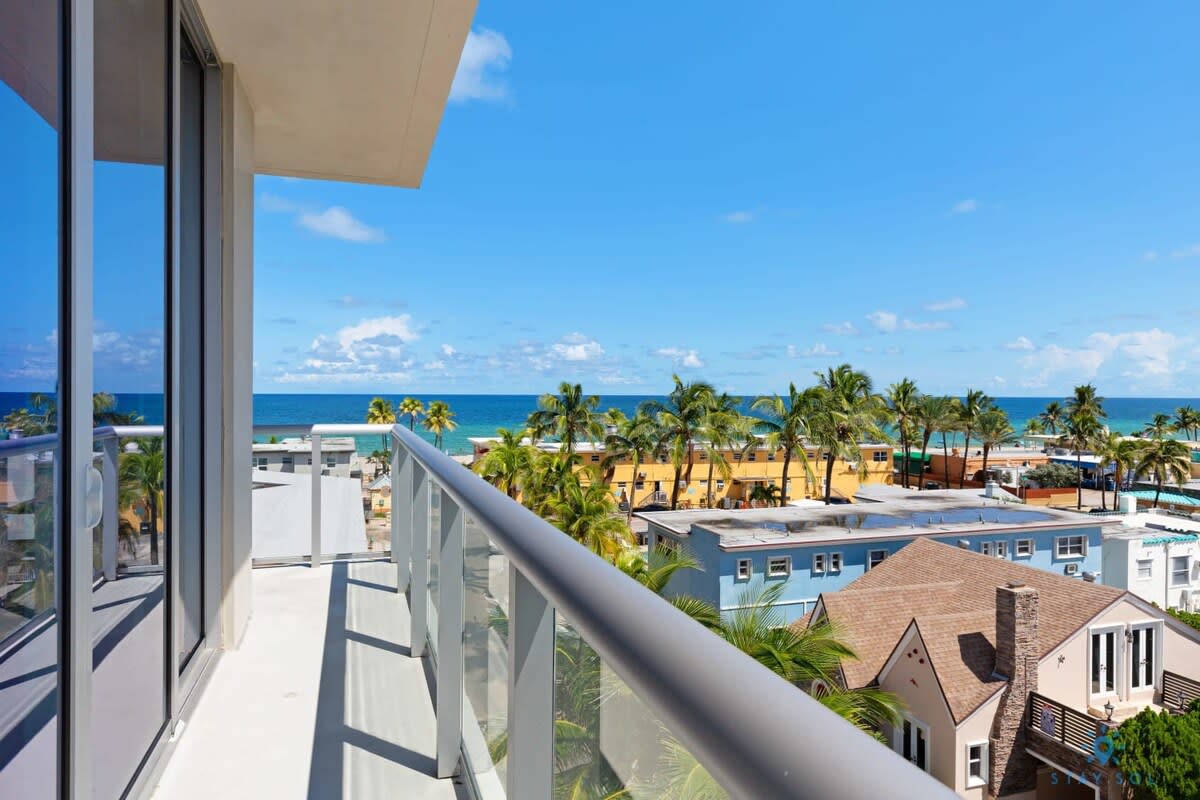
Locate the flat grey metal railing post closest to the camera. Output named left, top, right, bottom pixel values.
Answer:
left=506, top=564, right=554, bottom=800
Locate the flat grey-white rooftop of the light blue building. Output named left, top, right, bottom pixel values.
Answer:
left=636, top=489, right=1114, bottom=548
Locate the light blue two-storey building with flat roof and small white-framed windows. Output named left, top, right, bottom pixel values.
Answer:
left=637, top=489, right=1115, bottom=622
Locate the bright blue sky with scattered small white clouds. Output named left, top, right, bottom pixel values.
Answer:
left=0, top=0, right=1200, bottom=397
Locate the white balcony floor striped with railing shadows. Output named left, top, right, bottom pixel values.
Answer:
left=154, top=561, right=463, bottom=800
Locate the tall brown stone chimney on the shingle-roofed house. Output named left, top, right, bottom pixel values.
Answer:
left=988, top=581, right=1039, bottom=798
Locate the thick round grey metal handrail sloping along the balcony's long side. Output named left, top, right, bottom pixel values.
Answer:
left=392, top=425, right=956, bottom=799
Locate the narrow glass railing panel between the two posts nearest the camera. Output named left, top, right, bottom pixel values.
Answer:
left=462, top=515, right=509, bottom=800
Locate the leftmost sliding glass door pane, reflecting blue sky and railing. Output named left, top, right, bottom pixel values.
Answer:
left=0, top=2, right=65, bottom=800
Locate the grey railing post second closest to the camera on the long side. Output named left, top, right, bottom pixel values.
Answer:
left=437, top=492, right=463, bottom=777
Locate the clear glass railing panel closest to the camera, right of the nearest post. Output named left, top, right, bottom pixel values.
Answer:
left=554, top=616, right=728, bottom=800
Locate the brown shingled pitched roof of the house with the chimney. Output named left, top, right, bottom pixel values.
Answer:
left=806, top=539, right=1124, bottom=722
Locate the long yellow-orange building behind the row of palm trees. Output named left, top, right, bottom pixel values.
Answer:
left=470, top=438, right=893, bottom=509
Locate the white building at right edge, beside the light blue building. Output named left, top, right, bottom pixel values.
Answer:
left=1102, top=511, right=1200, bottom=612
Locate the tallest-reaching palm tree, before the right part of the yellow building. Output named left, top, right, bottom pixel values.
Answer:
left=809, top=363, right=888, bottom=505
